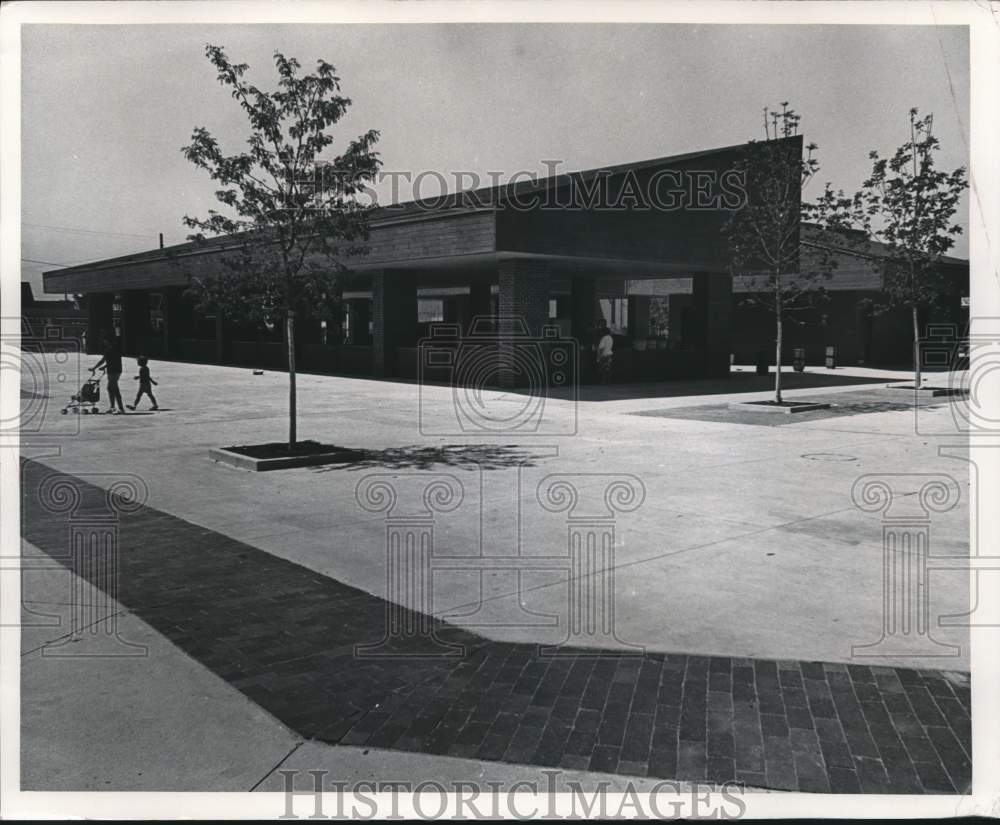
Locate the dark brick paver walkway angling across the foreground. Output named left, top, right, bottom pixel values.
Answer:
left=22, top=461, right=971, bottom=793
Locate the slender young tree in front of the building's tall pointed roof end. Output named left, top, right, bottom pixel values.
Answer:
left=724, top=103, right=848, bottom=404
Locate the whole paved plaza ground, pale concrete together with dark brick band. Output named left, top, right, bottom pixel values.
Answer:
left=22, top=362, right=971, bottom=793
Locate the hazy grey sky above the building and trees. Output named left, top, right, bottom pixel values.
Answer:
left=21, top=23, right=969, bottom=297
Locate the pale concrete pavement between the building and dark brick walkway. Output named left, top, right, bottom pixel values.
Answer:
left=21, top=354, right=968, bottom=668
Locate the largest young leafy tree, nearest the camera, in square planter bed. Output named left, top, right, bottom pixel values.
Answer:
left=182, top=44, right=381, bottom=451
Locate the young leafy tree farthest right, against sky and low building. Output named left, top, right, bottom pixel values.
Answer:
left=855, top=109, right=967, bottom=387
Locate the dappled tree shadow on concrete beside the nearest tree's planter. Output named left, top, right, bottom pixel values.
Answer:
left=310, top=444, right=545, bottom=473
